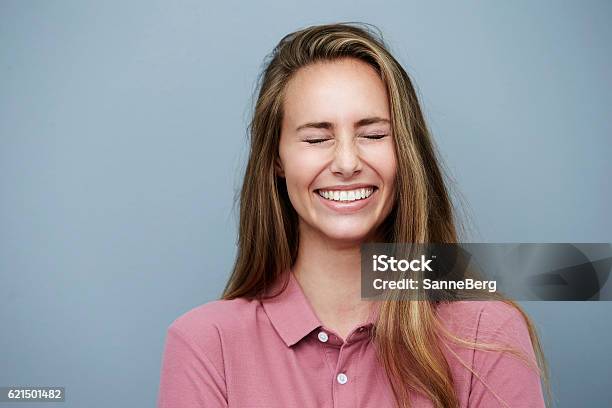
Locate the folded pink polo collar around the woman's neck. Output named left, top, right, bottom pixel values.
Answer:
left=261, top=270, right=378, bottom=347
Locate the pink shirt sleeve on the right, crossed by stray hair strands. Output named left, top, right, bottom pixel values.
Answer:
left=468, top=302, right=546, bottom=408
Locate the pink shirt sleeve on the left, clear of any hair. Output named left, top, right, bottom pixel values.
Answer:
left=157, top=326, right=228, bottom=408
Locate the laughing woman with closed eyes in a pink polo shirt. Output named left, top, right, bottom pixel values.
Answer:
left=159, top=23, right=546, bottom=408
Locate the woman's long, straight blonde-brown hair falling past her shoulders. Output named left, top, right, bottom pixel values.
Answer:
left=222, top=23, right=550, bottom=408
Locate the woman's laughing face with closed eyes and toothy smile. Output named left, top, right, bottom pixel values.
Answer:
left=277, top=58, right=396, bottom=242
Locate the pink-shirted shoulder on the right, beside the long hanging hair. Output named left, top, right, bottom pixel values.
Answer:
left=437, top=300, right=545, bottom=408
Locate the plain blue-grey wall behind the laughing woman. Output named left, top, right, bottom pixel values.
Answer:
left=0, top=0, right=612, bottom=408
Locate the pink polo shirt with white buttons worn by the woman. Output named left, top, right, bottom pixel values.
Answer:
left=158, top=273, right=545, bottom=408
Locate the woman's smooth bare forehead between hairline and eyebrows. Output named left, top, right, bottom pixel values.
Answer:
left=283, top=58, right=389, bottom=125
